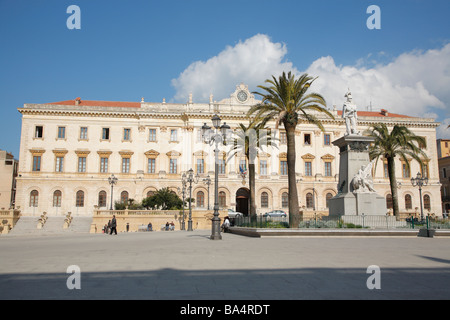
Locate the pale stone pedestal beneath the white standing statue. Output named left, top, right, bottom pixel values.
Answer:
left=329, top=135, right=387, bottom=216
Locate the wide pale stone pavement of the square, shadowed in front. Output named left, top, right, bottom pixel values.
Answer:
left=0, top=230, right=450, bottom=300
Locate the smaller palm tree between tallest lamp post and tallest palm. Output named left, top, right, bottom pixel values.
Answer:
left=228, top=120, right=276, bottom=219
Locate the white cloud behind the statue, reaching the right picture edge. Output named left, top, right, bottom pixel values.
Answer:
left=306, top=45, right=450, bottom=116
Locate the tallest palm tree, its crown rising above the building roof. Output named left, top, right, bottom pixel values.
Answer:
left=248, top=72, right=334, bottom=228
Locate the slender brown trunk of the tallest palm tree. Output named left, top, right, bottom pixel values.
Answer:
left=284, top=121, right=300, bottom=228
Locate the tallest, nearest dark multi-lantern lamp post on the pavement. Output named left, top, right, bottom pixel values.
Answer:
left=202, top=114, right=230, bottom=240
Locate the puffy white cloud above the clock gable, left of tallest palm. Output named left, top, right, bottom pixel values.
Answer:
left=172, top=34, right=296, bottom=102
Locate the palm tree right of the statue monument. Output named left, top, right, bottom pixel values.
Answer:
left=365, top=123, right=427, bottom=216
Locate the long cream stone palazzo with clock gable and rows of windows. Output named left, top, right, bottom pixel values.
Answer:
left=16, top=84, right=442, bottom=216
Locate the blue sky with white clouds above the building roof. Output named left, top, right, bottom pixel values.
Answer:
left=0, top=0, right=450, bottom=158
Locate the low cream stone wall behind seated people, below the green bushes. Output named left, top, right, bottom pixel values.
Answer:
left=90, top=210, right=226, bottom=233
